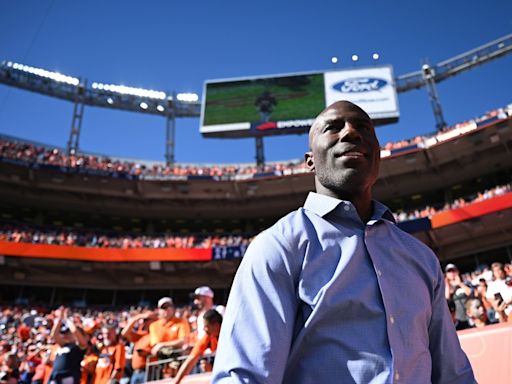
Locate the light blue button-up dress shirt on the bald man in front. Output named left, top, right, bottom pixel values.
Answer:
left=213, top=193, right=475, bottom=384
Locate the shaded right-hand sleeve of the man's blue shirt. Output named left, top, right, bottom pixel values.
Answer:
left=428, top=268, right=476, bottom=384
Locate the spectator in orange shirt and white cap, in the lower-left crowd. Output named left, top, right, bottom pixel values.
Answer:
left=149, top=297, right=190, bottom=357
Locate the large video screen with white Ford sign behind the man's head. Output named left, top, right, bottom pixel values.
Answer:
left=200, top=66, right=399, bottom=137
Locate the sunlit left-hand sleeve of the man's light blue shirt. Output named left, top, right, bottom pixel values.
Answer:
left=212, top=230, right=300, bottom=384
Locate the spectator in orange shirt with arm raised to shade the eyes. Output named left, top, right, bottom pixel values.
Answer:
left=121, top=312, right=156, bottom=384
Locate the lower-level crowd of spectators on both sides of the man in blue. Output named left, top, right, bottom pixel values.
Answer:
left=0, top=263, right=512, bottom=384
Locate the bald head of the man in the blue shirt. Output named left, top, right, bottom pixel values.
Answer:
left=305, top=101, right=380, bottom=200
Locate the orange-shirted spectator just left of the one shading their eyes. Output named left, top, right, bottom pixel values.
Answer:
left=94, top=324, right=126, bottom=384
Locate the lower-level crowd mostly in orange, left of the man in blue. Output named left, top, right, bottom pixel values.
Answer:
left=0, top=286, right=224, bottom=384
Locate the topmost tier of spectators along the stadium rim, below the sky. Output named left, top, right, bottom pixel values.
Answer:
left=0, top=105, right=512, bottom=180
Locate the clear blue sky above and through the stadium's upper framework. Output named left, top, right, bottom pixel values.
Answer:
left=0, top=0, right=512, bottom=163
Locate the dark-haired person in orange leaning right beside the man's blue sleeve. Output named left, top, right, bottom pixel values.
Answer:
left=174, top=309, right=222, bottom=384
